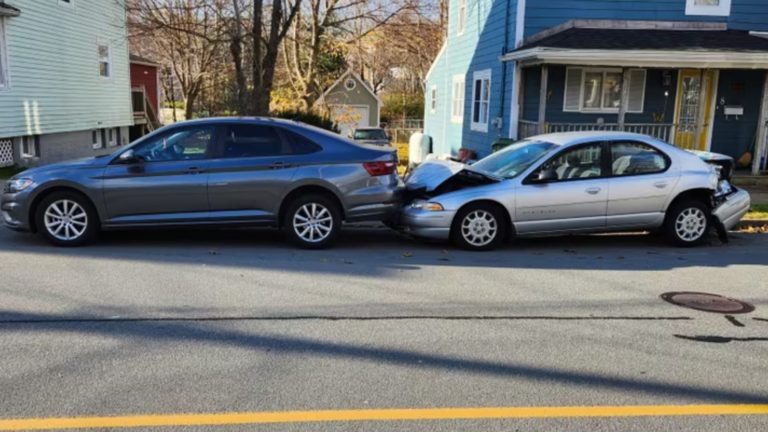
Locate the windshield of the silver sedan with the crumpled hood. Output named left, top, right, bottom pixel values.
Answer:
left=471, top=140, right=557, bottom=179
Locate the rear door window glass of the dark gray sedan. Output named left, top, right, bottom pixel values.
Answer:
left=222, top=124, right=289, bottom=158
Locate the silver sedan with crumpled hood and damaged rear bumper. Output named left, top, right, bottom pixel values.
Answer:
left=400, top=132, right=750, bottom=250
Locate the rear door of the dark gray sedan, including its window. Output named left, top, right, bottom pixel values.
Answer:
left=208, top=122, right=316, bottom=220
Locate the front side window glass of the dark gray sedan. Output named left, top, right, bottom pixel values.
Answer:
left=134, top=126, right=216, bottom=162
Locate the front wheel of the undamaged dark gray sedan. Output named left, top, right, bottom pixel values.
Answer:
left=35, top=192, right=99, bottom=247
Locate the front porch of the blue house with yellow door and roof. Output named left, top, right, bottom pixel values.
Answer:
left=504, top=23, right=768, bottom=174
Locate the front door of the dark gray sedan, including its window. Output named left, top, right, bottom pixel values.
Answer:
left=103, top=125, right=216, bottom=224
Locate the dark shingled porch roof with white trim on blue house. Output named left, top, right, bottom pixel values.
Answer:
left=502, top=28, right=768, bottom=69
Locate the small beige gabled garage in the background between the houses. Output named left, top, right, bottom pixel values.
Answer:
left=318, top=71, right=382, bottom=136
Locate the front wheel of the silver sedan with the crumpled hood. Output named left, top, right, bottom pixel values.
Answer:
left=451, top=203, right=508, bottom=251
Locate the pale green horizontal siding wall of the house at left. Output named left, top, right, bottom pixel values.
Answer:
left=0, top=0, right=133, bottom=138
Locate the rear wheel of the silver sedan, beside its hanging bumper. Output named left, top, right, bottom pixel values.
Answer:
left=664, top=200, right=712, bottom=247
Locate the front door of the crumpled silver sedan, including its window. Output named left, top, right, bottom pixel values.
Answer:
left=515, top=142, right=608, bottom=234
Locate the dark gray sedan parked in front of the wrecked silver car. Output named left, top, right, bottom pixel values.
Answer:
left=2, top=118, right=402, bottom=248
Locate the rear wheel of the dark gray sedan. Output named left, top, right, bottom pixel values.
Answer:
left=282, top=195, right=341, bottom=249
